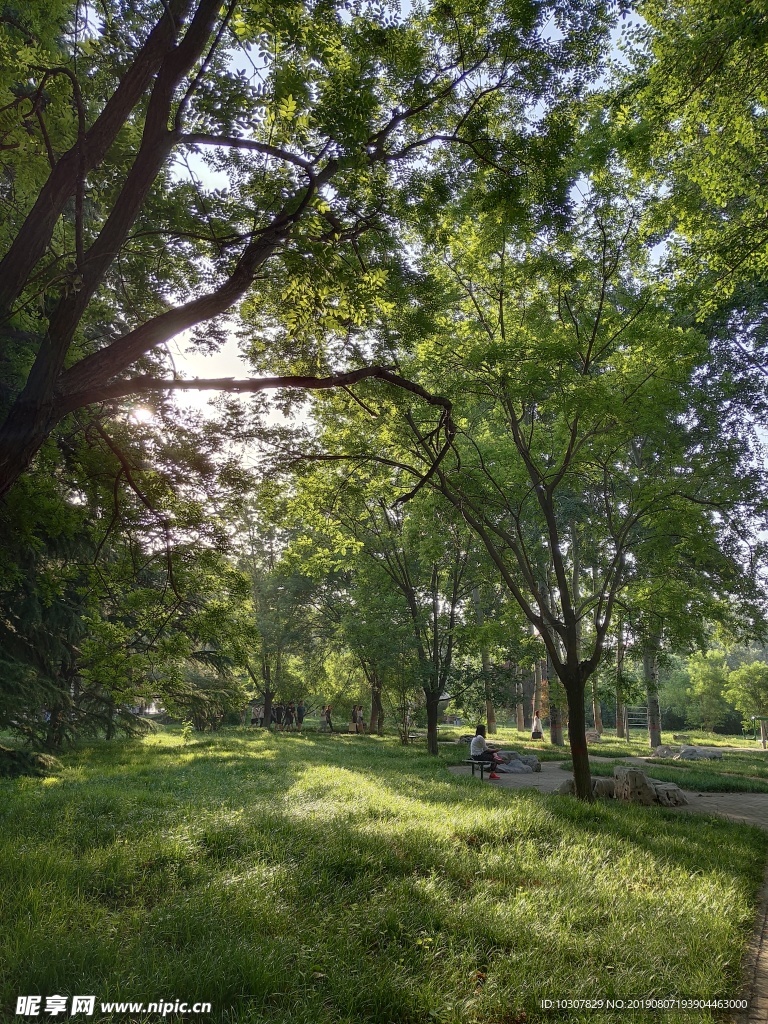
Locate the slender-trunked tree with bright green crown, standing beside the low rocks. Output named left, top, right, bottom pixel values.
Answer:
left=319, top=188, right=760, bottom=799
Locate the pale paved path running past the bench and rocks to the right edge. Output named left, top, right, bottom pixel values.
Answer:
left=450, top=758, right=768, bottom=1024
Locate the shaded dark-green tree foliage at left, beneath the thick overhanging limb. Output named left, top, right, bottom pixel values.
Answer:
left=0, top=385, right=259, bottom=745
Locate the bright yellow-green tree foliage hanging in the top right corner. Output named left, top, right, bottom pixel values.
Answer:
left=618, top=0, right=768, bottom=314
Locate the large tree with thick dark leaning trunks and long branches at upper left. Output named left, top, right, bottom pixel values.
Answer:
left=0, top=0, right=618, bottom=495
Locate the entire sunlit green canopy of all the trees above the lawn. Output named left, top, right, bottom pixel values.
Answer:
left=0, top=0, right=766, bottom=799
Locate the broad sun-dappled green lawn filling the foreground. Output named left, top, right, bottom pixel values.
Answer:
left=0, top=729, right=768, bottom=1024
